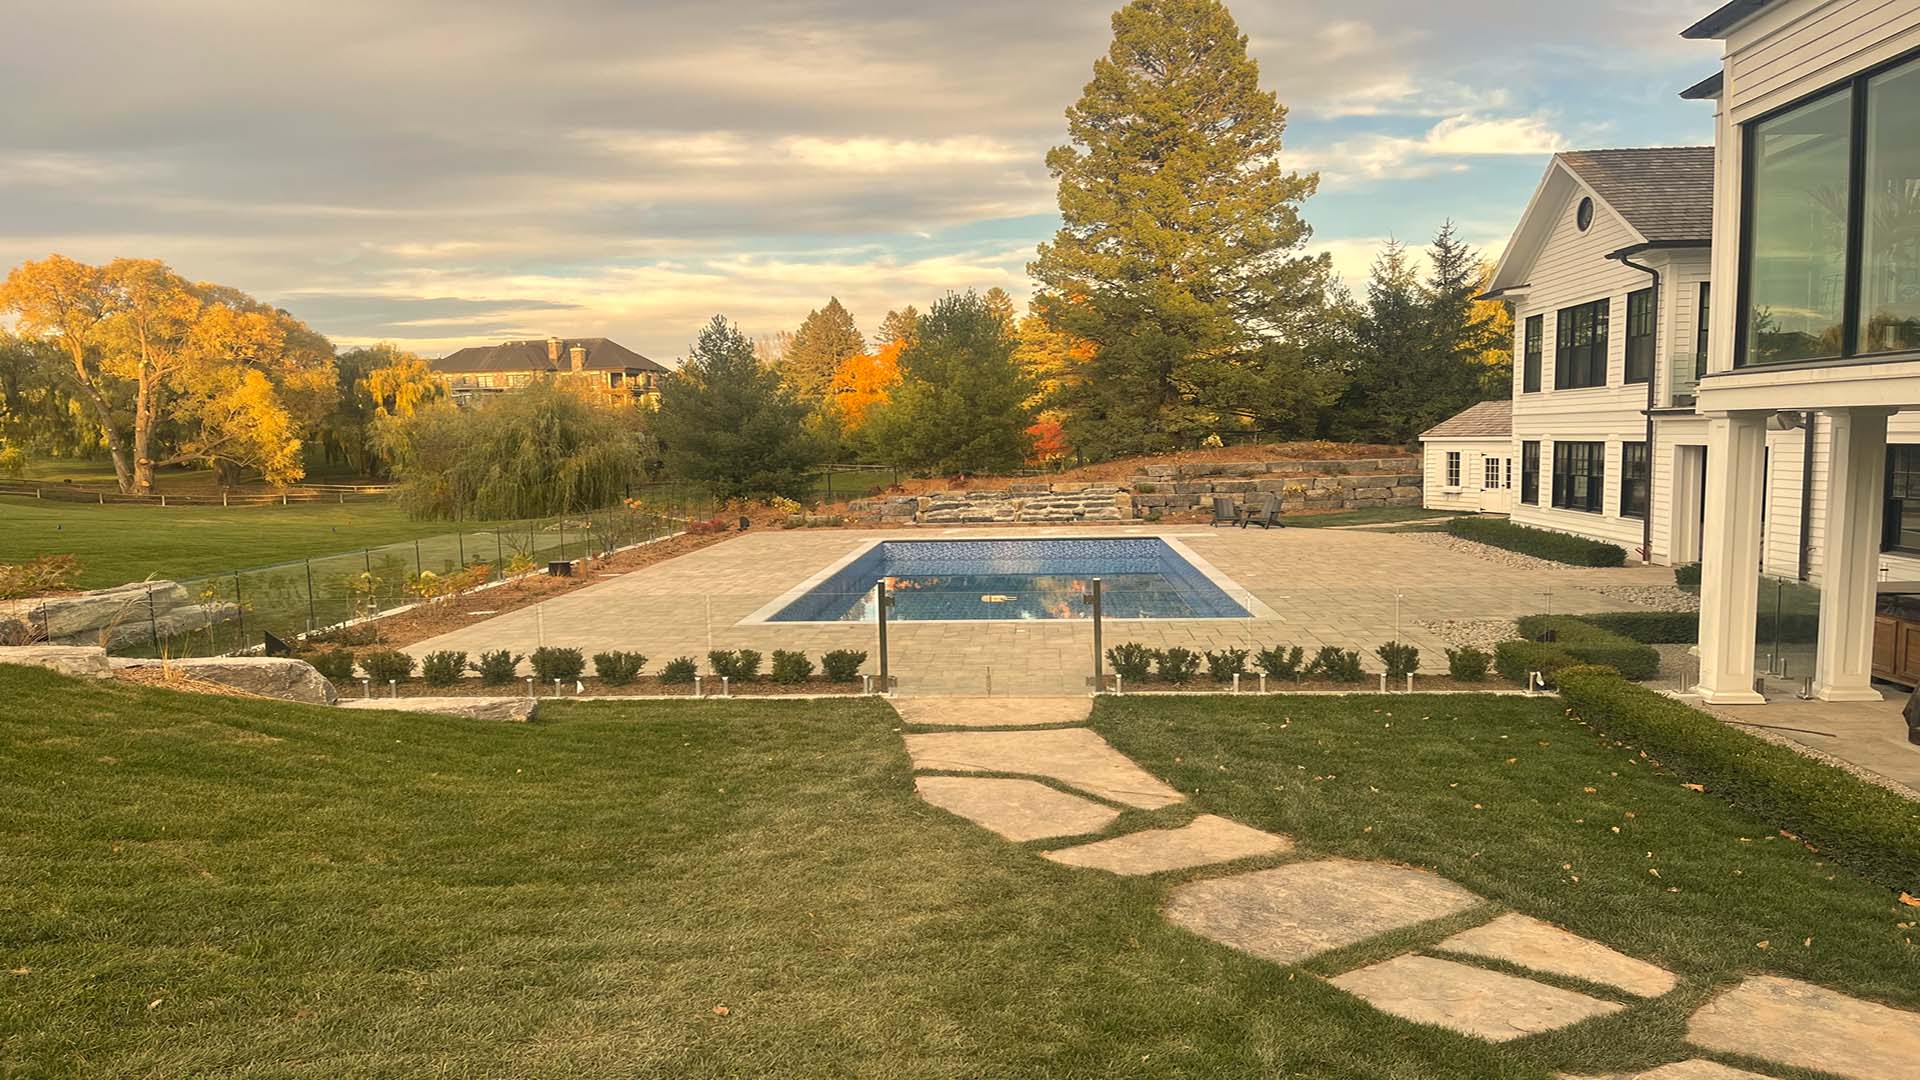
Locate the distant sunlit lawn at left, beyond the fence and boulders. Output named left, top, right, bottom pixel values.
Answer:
left=0, top=498, right=462, bottom=588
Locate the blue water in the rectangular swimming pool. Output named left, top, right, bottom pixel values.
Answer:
left=770, top=536, right=1248, bottom=623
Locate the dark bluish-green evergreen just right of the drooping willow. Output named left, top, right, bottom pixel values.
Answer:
left=653, top=315, right=822, bottom=498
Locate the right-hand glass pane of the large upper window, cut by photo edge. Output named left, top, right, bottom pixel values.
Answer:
left=1859, top=63, right=1920, bottom=352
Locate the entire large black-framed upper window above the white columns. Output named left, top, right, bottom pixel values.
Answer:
left=1734, top=54, right=1920, bottom=365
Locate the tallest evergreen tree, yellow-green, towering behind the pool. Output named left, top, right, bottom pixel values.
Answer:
left=1029, top=0, right=1329, bottom=457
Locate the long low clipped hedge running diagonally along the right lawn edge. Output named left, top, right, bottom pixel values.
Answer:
left=1561, top=667, right=1920, bottom=894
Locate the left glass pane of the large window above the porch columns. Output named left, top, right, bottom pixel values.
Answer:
left=1745, top=90, right=1853, bottom=363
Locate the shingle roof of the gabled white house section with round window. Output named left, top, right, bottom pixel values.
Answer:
left=1559, top=146, right=1713, bottom=244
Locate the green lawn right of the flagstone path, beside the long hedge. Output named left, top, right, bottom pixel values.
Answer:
left=1094, top=696, right=1920, bottom=1076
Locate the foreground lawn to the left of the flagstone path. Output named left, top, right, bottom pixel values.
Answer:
left=0, top=669, right=1546, bottom=1080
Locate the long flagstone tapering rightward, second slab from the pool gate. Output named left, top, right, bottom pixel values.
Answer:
left=906, top=728, right=1181, bottom=809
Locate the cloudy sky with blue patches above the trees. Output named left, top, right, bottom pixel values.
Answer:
left=0, top=0, right=1718, bottom=361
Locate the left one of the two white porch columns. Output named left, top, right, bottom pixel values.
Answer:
left=1697, top=413, right=1766, bottom=705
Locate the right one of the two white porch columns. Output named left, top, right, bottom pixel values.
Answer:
left=1812, top=409, right=1887, bottom=701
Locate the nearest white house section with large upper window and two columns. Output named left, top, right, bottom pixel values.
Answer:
left=1686, top=0, right=1920, bottom=703
